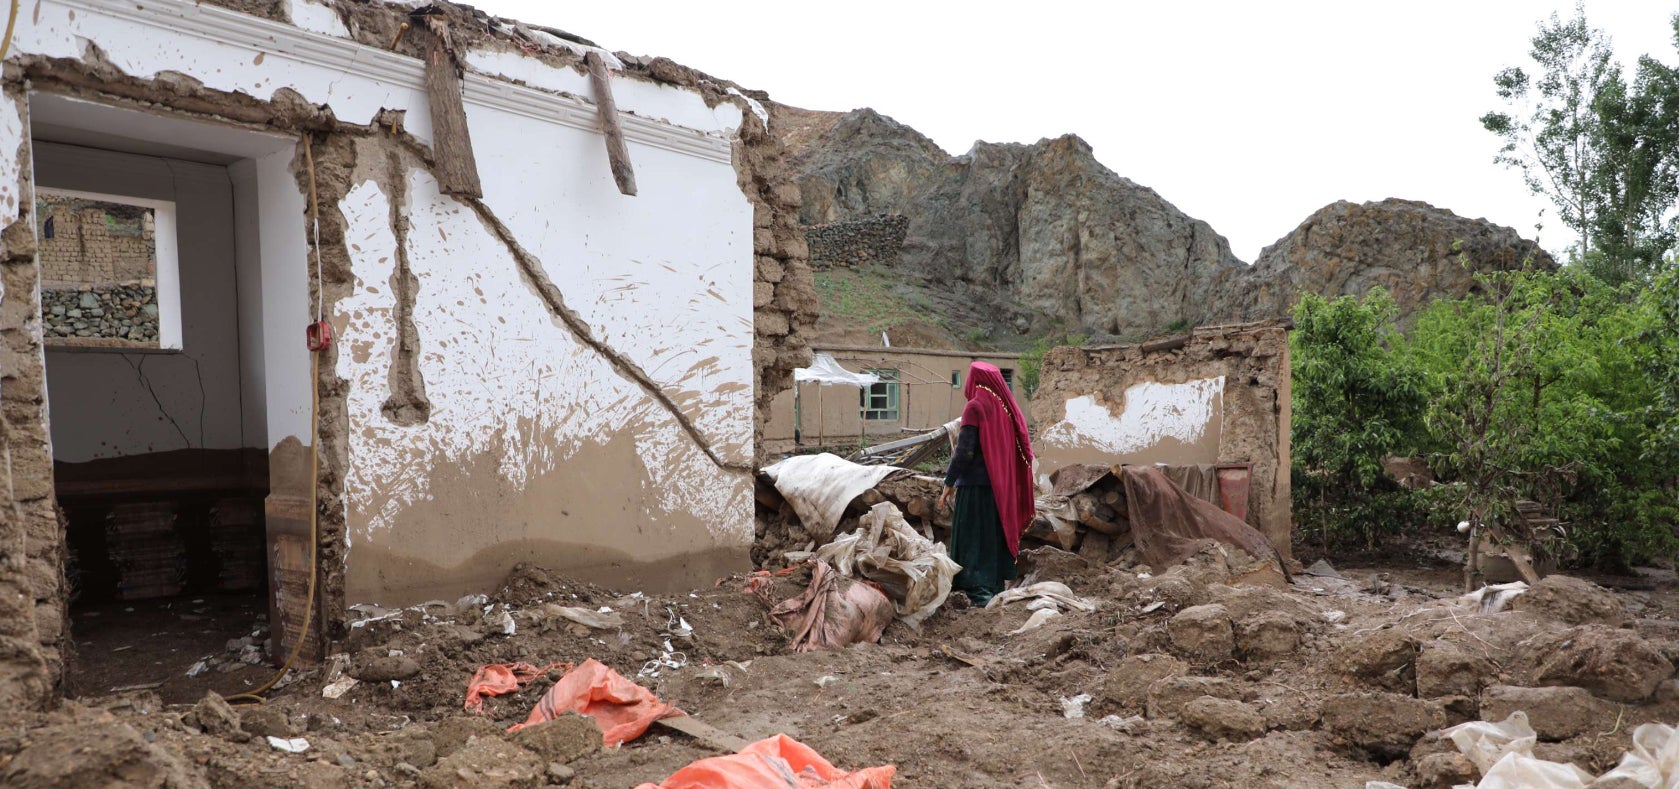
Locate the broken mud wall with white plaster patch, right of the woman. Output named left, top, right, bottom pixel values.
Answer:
left=1031, top=322, right=1293, bottom=556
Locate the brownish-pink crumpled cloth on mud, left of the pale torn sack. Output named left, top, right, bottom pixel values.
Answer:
left=769, top=561, right=893, bottom=651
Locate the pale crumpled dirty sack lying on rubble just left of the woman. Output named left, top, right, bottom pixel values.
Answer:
left=809, top=502, right=962, bottom=626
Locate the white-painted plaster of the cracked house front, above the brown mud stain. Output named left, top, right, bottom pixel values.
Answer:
left=11, top=0, right=756, bottom=603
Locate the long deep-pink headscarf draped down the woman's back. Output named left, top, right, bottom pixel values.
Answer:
left=962, top=361, right=1036, bottom=556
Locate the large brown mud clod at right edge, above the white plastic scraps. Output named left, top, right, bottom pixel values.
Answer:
left=1523, top=624, right=1674, bottom=702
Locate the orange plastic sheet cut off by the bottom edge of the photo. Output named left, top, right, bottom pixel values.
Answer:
left=636, top=734, right=898, bottom=789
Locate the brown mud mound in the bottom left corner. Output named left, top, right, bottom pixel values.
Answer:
left=0, top=722, right=210, bottom=789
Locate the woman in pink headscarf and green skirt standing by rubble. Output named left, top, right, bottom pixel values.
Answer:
left=939, top=361, right=1034, bottom=606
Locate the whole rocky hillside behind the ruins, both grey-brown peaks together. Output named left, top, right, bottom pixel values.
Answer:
left=774, top=106, right=1551, bottom=347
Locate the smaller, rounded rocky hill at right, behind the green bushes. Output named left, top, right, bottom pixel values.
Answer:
left=1209, top=200, right=1556, bottom=327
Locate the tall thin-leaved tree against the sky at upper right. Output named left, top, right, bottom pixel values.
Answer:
left=1481, top=5, right=1679, bottom=284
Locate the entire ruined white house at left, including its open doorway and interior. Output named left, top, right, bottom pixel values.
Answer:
left=0, top=0, right=814, bottom=703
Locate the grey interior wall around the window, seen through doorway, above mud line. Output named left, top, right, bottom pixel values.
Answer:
left=35, top=143, right=260, bottom=462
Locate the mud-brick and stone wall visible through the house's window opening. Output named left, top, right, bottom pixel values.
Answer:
left=35, top=195, right=158, bottom=287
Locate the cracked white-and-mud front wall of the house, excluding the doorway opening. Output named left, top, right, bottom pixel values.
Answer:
left=0, top=0, right=816, bottom=698
